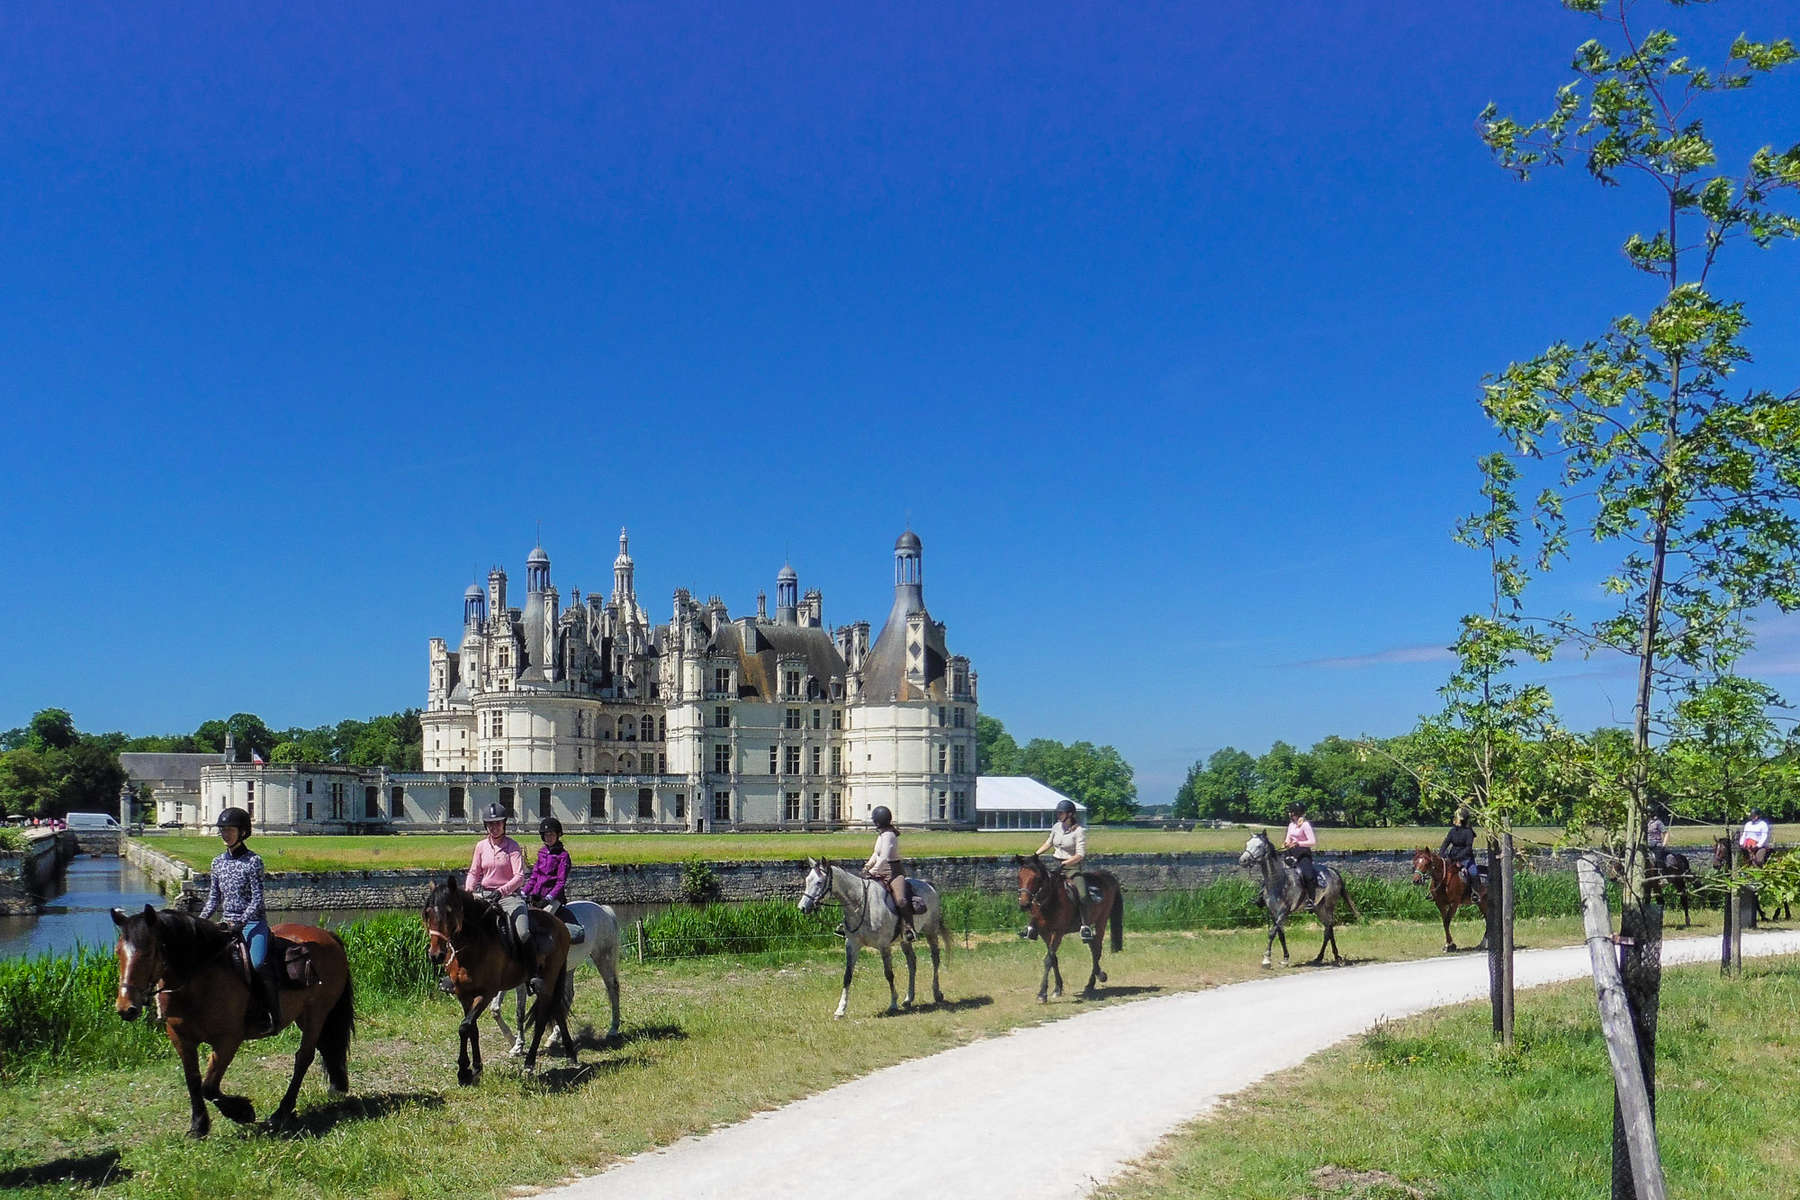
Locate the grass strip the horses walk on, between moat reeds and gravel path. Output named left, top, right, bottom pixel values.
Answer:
left=0, top=914, right=1605, bottom=1198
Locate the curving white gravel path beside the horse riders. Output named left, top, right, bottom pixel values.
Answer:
left=544, top=932, right=1800, bottom=1200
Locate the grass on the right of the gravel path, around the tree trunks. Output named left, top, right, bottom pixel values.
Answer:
left=1096, top=957, right=1800, bottom=1200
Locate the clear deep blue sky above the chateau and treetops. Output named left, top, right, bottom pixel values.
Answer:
left=0, top=0, right=1800, bottom=801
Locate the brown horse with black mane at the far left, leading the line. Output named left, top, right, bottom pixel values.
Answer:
left=112, top=905, right=356, bottom=1137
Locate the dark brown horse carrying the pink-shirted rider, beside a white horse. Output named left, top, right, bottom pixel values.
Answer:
left=419, top=873, right=576, bottom=1087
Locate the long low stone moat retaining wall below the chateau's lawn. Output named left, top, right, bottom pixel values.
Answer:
left=126, top=842, right=1571, bottom=912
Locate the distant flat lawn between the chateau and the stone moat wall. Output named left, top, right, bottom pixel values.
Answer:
left=146, top=822, right=1684, bottom=871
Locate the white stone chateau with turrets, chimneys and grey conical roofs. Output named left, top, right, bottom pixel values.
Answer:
left=195, top=531, right=976, bottom=833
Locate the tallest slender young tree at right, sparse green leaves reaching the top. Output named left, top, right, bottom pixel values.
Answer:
left=1481, top=0, right=1800, bottom=1196
